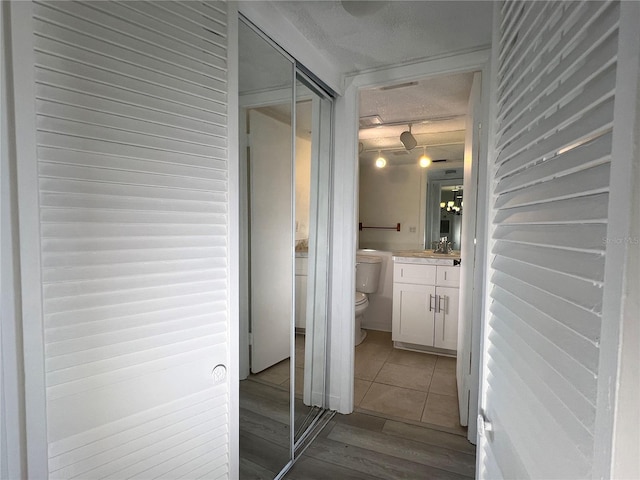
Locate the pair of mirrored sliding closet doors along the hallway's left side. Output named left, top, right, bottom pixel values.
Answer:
left=239, top=15, right=332, bottom=477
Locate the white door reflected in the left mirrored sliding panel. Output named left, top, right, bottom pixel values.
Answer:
left=249, top=109, right=294, bottom=373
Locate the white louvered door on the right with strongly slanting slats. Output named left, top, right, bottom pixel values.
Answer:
left=479, top=1, right=620, bottom=479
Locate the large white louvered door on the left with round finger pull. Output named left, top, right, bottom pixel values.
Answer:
left=12, top=1, right=230, bottom=479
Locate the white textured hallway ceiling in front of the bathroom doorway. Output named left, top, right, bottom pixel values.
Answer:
left=273, top=0, right=492, bottom=73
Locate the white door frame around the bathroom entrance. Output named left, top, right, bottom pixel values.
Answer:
left=330, top=48, right=491, bottom=446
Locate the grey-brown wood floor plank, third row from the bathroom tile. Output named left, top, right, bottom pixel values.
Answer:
left=304, top=437, right=469, bottom=480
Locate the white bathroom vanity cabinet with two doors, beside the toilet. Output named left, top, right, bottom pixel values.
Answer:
left=392, top=263, right=460, bottom=351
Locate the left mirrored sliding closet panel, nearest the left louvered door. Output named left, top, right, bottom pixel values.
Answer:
left=238, top=16, right=294, bottom=477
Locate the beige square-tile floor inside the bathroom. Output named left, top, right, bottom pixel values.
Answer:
left=354, top=330, right=466, bottom=435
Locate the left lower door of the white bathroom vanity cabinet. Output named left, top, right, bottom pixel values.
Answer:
left=393, top=283, right=435, bottom=346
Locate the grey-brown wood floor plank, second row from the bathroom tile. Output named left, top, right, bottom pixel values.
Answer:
left=327, top=424, right=475, bottom=477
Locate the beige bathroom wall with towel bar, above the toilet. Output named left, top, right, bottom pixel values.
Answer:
left=359, top=163, right=426, bottom=251
